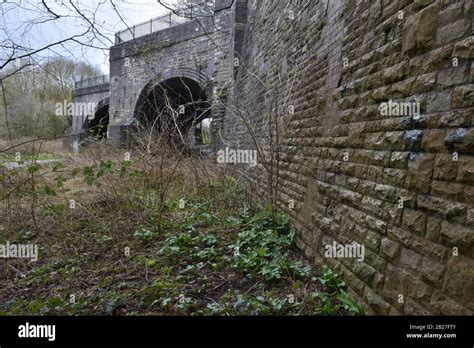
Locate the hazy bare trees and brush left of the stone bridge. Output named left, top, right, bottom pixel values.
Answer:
left=0, top=57, right=101, bottom=142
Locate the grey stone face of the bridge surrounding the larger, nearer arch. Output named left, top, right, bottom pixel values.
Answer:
left=108, top=1, right=234, bottom=146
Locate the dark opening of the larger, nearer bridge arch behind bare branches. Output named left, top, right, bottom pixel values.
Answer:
left=134, top=77, right=210, bottom=149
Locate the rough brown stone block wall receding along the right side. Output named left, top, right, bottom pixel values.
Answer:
left=224, top=0, right=474, bottom=315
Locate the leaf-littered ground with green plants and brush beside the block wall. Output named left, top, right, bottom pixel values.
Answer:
left=0, top=144, right=362, bottom=315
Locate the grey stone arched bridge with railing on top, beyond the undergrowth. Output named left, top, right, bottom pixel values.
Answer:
left=73, top=0, right=246, bottom=146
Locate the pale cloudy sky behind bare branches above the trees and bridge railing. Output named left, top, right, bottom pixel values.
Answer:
left=0, top=0, right=180, bottom=74
